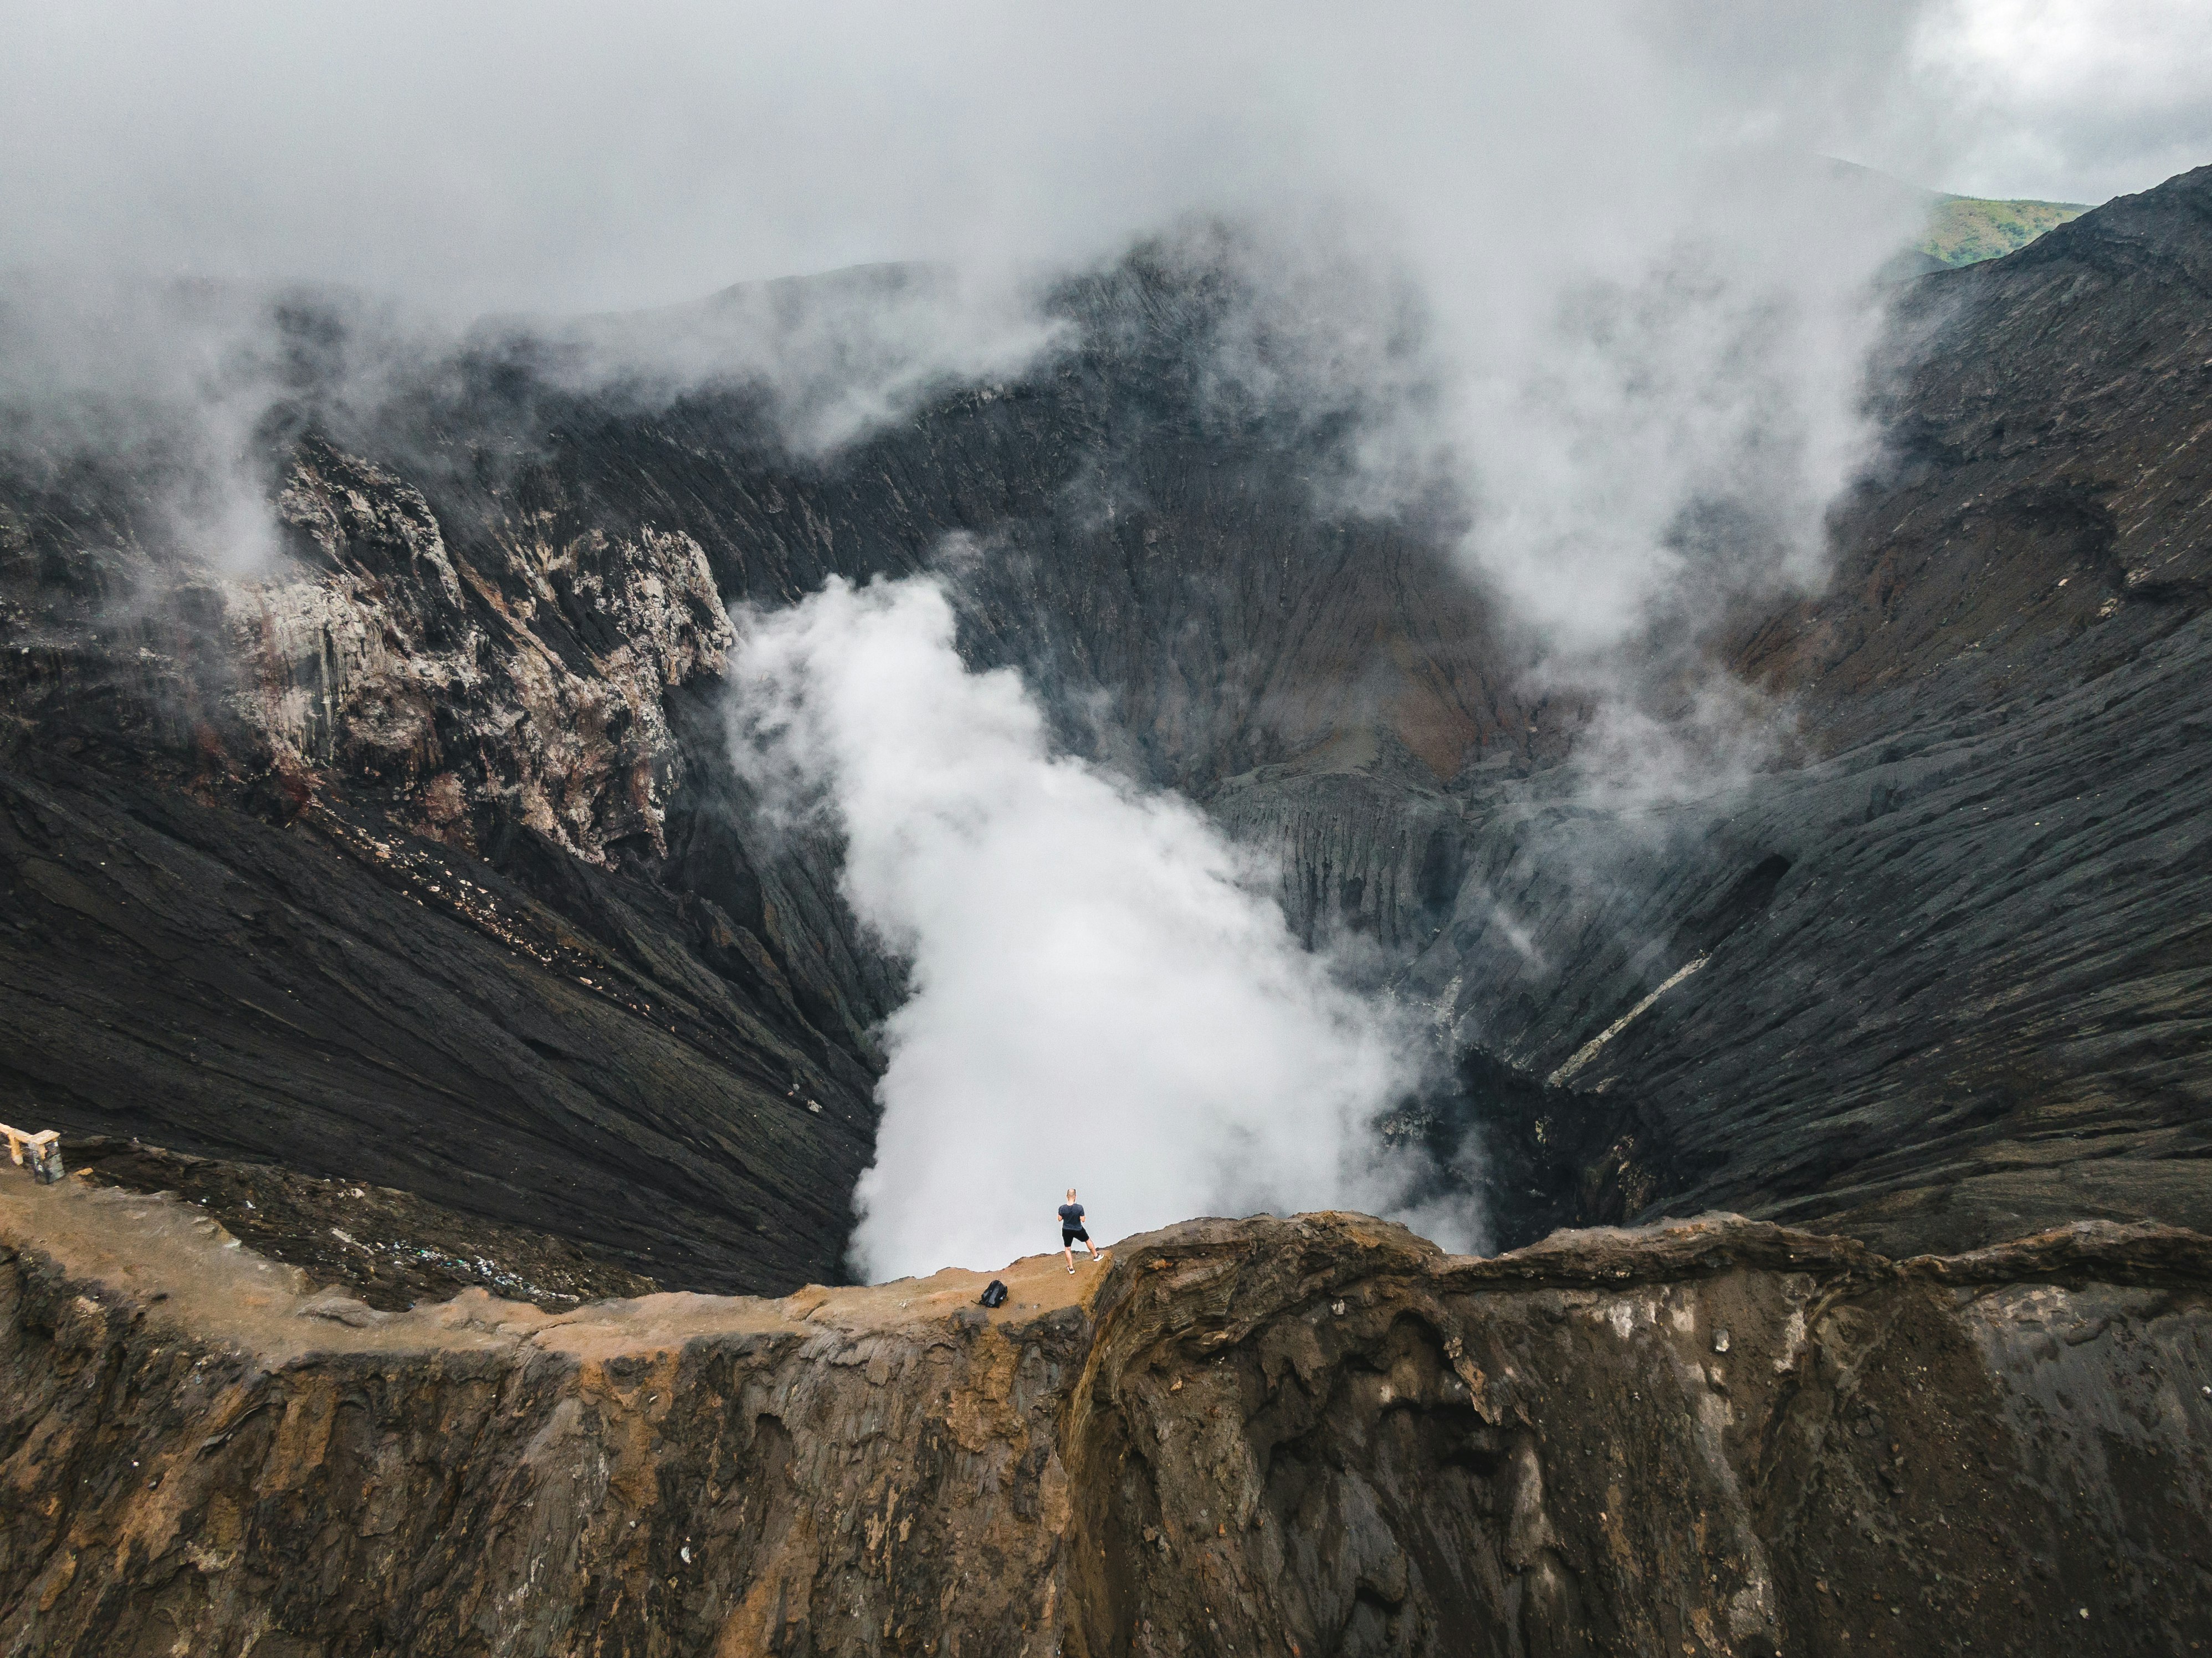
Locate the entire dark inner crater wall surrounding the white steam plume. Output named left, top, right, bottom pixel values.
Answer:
left=0, top=171, right=2212, bottom=1288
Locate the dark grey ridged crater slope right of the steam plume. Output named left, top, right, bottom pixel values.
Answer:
left=1416, top=168, right=2212, bottom=1253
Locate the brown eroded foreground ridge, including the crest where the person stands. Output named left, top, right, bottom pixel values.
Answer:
left=0, top=1182, right=2212, bottom=1658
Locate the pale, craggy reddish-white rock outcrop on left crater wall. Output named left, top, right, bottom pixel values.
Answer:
left=248, top=443, right=734, bottom=863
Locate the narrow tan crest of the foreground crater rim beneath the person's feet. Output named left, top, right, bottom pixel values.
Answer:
left=0, top=1180, right=2212, bottom=1366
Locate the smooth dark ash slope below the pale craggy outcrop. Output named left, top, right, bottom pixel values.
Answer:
left=0, top=770, right=874, bottom=1288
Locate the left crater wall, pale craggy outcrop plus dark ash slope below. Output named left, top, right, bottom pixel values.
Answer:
left=0, top=414, right=894, bottom=1288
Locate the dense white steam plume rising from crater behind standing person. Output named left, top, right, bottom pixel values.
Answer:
left=732, top=578, right=1476, bottom=1277
